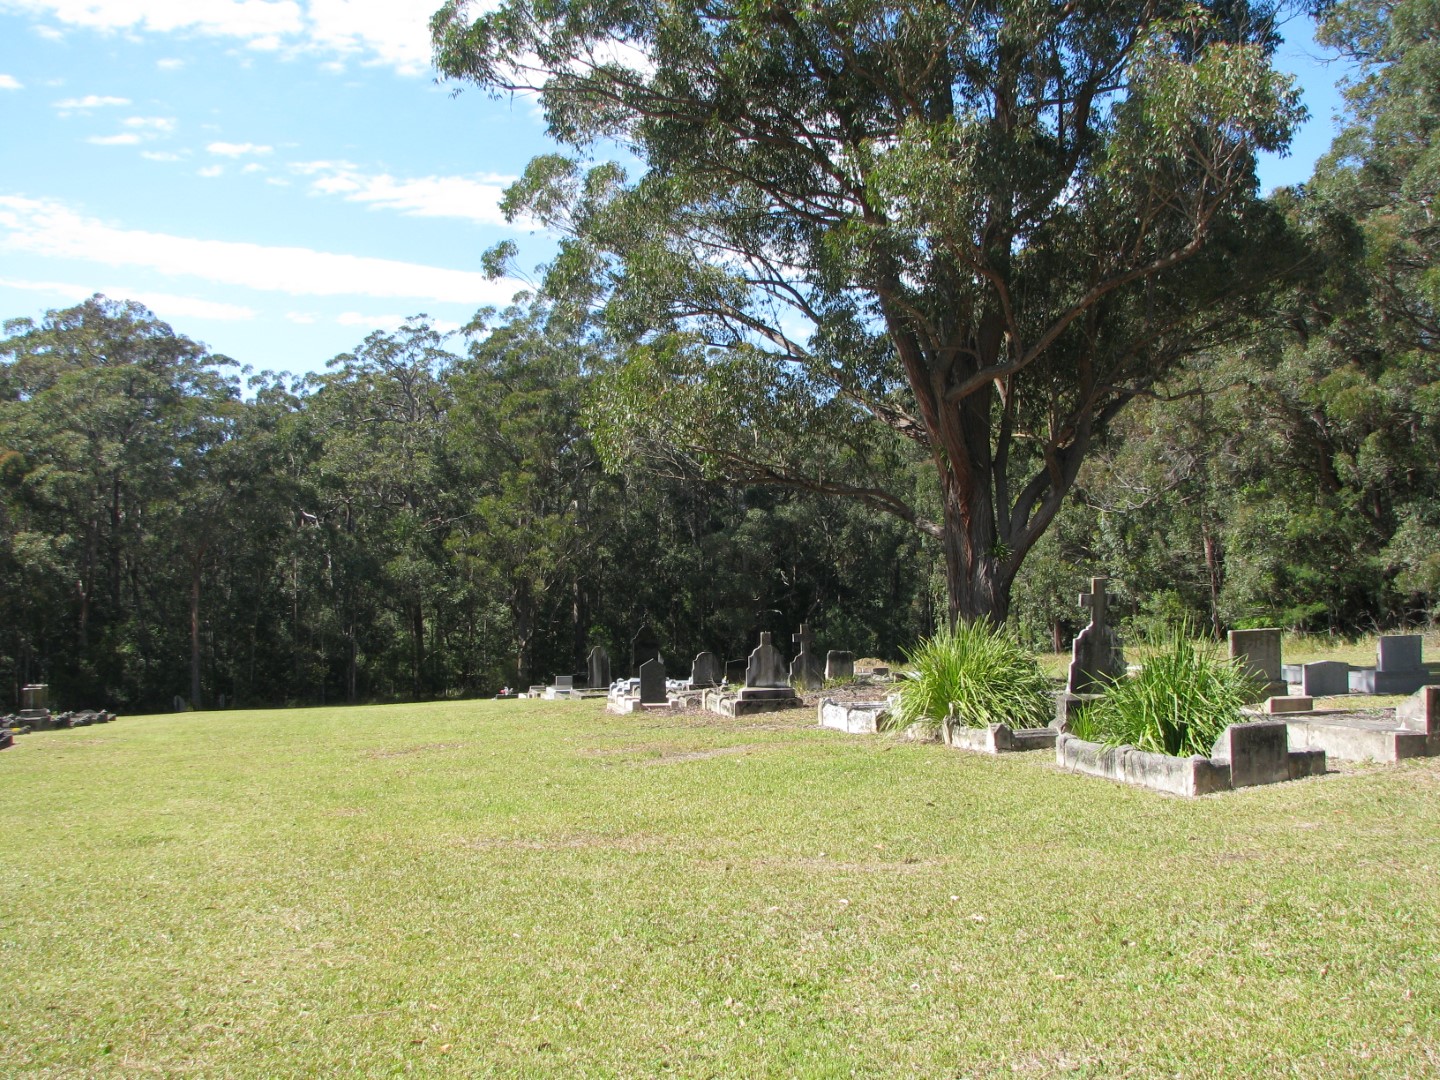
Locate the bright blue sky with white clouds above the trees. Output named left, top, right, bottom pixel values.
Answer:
left=0, top=0, right=1339, bottom=372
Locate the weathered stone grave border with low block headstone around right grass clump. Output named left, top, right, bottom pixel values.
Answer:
left=1056, top=720, right=1325, bottom=795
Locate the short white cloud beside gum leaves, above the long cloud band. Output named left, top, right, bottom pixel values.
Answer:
left=291, top=161, right=514, bottom=225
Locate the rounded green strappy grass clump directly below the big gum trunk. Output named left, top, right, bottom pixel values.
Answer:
left=893, top=621, right=1054, bottom=733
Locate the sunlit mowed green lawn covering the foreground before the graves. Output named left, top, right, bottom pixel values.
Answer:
left=0, top=701, right=1440, bottom=1077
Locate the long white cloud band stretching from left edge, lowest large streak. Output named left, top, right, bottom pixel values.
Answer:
left=0, top=196, right=523, bottom=307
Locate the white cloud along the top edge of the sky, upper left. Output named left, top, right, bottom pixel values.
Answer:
left=4, top=0, right=455, bottom=75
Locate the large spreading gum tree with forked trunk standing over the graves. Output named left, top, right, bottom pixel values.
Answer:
left=432, top=0, right=1302, bottom=622
